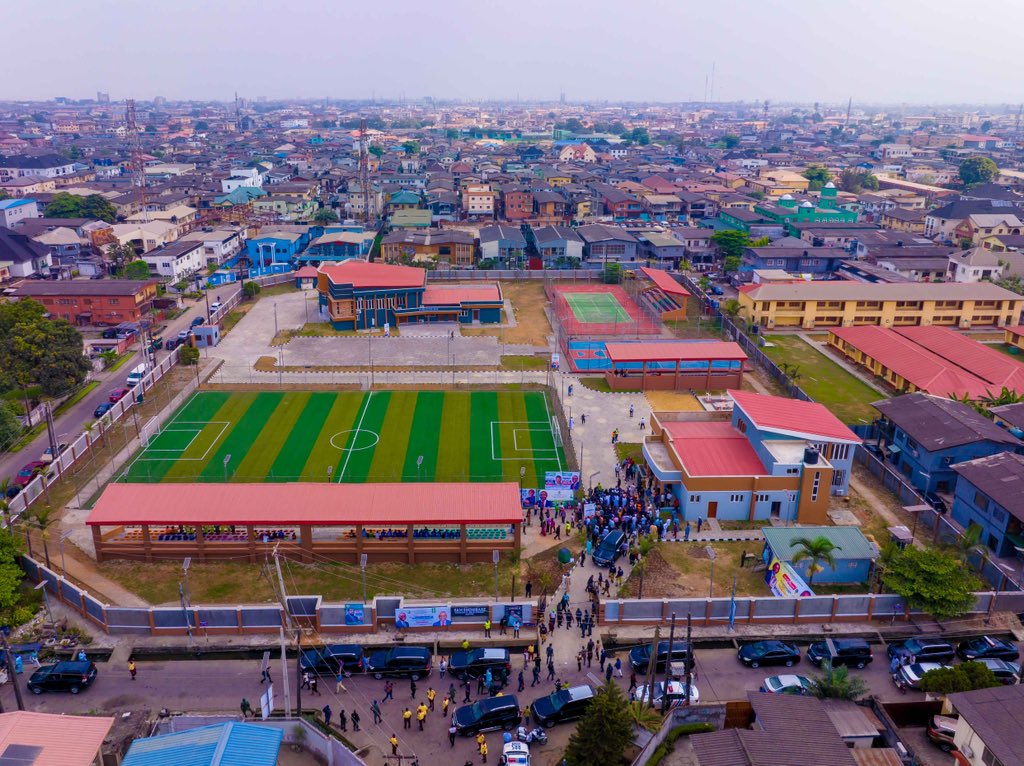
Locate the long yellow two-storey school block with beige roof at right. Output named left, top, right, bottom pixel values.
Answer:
left=738, top=281, right=1024, bottom=330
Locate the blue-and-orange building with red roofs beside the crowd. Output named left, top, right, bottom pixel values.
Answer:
left=643, top=390, right=860, bottom=524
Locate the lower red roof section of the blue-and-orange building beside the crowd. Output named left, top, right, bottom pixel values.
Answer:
left=662, top=420, right=768, bottom=476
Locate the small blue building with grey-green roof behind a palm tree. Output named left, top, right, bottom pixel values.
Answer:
left=761, top=526, right=879, bottom=588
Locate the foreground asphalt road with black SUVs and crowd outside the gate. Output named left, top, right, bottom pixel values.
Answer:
left=0, top=646, right=918, bottom=766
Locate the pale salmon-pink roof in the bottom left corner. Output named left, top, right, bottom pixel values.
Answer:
left=0, top=711, right=114, bottom=766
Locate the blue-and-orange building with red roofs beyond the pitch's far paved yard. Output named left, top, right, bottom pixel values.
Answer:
left=316, top=259, right=505, bottom=330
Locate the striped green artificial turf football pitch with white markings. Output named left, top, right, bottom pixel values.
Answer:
left=120, top=391, right=565, bottom=487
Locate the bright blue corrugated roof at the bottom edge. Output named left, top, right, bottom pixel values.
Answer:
left=121, top=721, right=284, bottom=766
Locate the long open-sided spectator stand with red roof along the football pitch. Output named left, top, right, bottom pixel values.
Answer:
left=86, top=482, right=522, bottom=563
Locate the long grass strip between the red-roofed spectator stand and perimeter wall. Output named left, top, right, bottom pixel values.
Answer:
left=97, top=550, right=561, bottom=604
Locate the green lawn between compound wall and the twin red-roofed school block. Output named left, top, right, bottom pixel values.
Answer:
left=763, top=335, right=885, bottom=424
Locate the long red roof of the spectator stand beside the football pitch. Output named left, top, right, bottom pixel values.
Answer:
left=86, top=481, right=522, bottom=526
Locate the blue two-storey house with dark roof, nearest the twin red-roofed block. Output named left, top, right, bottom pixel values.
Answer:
left=872, top=391, right=1024, bottom=493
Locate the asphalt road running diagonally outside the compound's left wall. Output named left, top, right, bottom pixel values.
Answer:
left=0, top=287, right=238, bottom=487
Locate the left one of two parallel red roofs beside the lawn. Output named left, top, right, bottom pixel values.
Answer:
left=829, top=326, right=998, bottom=399
